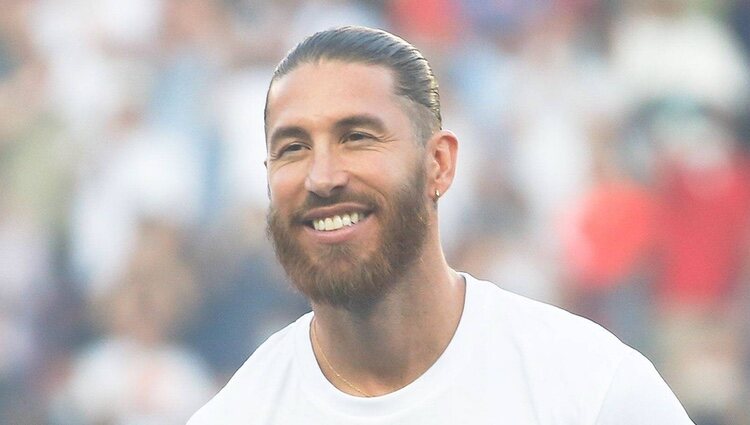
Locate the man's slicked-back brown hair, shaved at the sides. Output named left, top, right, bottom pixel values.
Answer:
left=264, top=26, right=442, bottom=143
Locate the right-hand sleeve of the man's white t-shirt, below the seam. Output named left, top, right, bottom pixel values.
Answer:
left=595, top=351, right=695, bottom=425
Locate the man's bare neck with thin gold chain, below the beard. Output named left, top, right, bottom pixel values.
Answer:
left=313, top=243, right=465, bottom=396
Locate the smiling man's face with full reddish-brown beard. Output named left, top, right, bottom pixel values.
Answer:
left=267, top=61, right=428, bottom=306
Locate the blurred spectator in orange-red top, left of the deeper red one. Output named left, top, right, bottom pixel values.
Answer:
left=561, top=140, right=658, bottom=354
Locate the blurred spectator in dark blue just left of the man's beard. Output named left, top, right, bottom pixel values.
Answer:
left=188, top=206, right=310, bottom=385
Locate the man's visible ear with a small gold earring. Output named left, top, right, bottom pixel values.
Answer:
left=426, top=130, right=458, bottom=202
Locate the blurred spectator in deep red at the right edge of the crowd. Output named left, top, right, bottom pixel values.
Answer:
left=652, top=101, right=750, bottom=309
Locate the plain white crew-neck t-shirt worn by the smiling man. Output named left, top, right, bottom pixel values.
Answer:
left=188, top=274, right=693, bottom=425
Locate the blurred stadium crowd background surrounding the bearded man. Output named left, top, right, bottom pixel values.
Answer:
left=0, top=0, right=750, bottom=425
